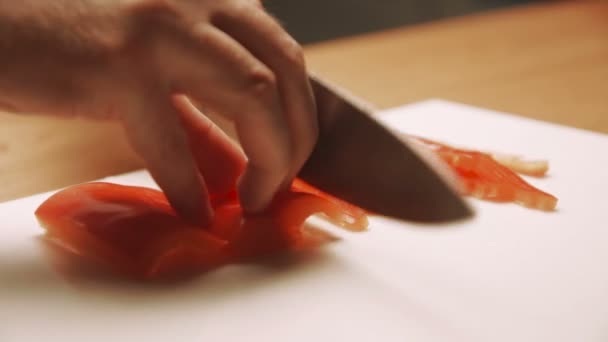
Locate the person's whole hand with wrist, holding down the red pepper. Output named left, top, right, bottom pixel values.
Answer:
left=0, top=0, right=318, bottom=223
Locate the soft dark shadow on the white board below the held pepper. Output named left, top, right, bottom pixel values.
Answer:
left=0, top=231, right=341, bottom=305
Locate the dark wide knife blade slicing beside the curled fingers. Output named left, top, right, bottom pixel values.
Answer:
left=298, top=75, right=472, bottom=223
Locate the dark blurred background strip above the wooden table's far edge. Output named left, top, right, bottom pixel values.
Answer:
left=263, top=0, right=533, bottom=44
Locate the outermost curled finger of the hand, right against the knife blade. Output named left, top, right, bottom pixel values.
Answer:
left=212, top=1, right=318, bottom=187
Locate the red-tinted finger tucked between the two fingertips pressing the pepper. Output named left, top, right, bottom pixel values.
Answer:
left=173, top=96, right=246, bottom=194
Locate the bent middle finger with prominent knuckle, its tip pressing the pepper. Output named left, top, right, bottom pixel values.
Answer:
left=168, top=25, right=292, bottom=212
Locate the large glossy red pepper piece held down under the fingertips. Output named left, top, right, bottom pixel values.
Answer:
left=35, top=180, right=367, bottom=279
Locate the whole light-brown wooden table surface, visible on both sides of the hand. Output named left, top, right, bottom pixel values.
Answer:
left=0, top=1, right=608, bottom=201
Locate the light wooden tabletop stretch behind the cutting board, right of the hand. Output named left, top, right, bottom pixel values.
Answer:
left=307, top=1, right=608, bottom=133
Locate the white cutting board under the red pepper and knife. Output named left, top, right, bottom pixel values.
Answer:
left=0, top=101, right=608, bottom=342
